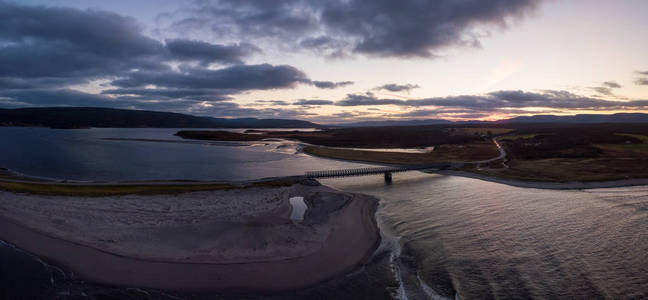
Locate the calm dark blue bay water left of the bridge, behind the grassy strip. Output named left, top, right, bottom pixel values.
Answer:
left=0, top=127, right=374, bottom=181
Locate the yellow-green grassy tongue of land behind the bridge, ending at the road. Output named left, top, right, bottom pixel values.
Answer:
left=304, top=142, right=499, bottom=165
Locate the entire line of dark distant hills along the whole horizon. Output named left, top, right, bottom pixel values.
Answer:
left=0, top=107, right=648, bottom=128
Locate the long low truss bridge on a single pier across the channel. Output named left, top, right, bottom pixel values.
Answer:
left=306, top=163, right=461, bottom=182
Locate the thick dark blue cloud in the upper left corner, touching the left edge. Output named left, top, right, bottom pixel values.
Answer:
left=0, top=1, right=164, bottom=81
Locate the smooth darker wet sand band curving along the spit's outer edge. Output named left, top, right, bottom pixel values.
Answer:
left=0, top=186, right=381, bottom=295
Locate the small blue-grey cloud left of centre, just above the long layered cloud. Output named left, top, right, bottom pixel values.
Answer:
left=166, top=39, right=261, bottom=64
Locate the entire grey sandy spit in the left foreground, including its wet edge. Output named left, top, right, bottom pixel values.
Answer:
left=0, top=184, right=380, bottom=294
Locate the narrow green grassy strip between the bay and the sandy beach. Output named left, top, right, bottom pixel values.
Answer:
left=0, top=178, right=296, bottom=197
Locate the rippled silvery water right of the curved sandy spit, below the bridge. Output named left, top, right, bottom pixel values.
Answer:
left=324, top=173, right=648, bottom=299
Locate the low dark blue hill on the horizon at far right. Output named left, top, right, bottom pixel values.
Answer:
left=496, top=113, right=648, bottom=124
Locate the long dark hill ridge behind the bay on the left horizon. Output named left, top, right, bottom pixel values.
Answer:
left=0, top=107, right=322, bottom=128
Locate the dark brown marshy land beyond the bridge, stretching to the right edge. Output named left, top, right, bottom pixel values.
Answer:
left=177, top=123, right=648, bottom=182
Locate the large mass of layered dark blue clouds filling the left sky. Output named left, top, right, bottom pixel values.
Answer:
left=0, top=0, right=324, bottom=107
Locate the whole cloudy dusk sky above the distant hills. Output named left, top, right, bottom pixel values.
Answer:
left=0, top=0, right=648, bottom=123
